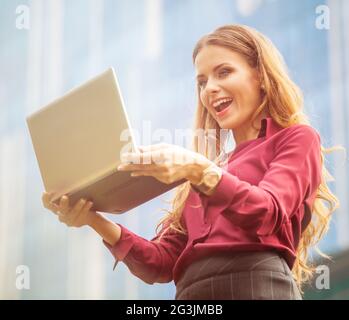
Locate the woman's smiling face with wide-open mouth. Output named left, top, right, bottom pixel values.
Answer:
left=195, top=45, right=262, bottom=142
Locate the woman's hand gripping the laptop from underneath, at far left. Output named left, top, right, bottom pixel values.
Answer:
left=42, top=192, right=96, bottom=228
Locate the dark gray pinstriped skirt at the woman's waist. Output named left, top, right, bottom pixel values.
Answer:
left=175, top=251, right=302, bottom=300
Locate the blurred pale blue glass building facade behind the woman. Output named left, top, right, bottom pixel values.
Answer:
left=0, top=0, right=349, bottom=299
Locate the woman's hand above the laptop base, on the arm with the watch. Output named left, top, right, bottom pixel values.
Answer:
left=118, top=143, right=212, bottom=184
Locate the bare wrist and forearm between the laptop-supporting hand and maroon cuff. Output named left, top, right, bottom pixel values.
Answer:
left=88, top=212, right=121, bottom=246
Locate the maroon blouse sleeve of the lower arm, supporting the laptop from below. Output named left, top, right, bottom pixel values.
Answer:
left=103, top=220, right=187, bottom=284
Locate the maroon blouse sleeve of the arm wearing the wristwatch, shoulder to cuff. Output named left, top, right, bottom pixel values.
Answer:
left=204, top=125, right=321, bottom=236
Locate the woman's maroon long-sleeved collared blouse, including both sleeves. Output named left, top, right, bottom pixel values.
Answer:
left=104, top=118, right=321, bottom=284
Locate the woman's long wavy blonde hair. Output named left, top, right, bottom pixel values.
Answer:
left=156, top=25, right=339, bottom=292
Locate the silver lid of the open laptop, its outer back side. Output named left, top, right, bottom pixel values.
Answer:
left=27, top=68, right=136, bottom=201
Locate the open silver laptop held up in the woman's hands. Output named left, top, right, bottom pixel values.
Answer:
left=26, top=68, right=185, bottom=214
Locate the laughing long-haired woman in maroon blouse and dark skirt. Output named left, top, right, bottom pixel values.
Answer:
left=43, top=25, right=338, bottom=299
